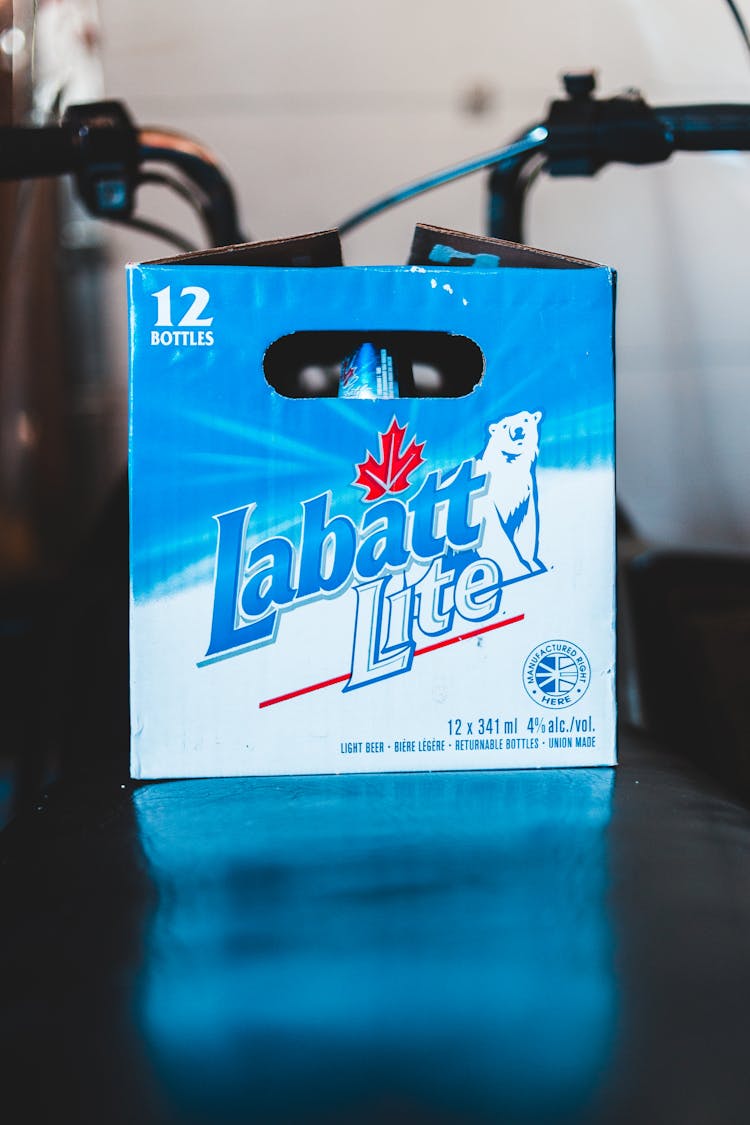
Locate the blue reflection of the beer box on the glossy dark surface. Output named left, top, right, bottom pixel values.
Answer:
left=134, top=770, right=616, bottom=1122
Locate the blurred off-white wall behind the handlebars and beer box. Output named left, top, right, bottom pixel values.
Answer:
left=100, top=0, right=750, bottom=548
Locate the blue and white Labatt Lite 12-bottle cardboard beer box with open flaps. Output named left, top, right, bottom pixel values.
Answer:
left=128, top=227, right=615, bottom=779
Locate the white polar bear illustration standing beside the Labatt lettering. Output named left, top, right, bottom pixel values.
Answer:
left=477, top=411, right=544, bottom=581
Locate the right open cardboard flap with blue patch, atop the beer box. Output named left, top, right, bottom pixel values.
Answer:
left=408, top=223, right=597, bottom=270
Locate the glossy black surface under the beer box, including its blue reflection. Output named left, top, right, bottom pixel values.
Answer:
left=0, top=731, right=750, bottom=1125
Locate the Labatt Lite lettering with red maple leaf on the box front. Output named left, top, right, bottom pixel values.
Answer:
left=201, top=417, right=526, bottom=691
